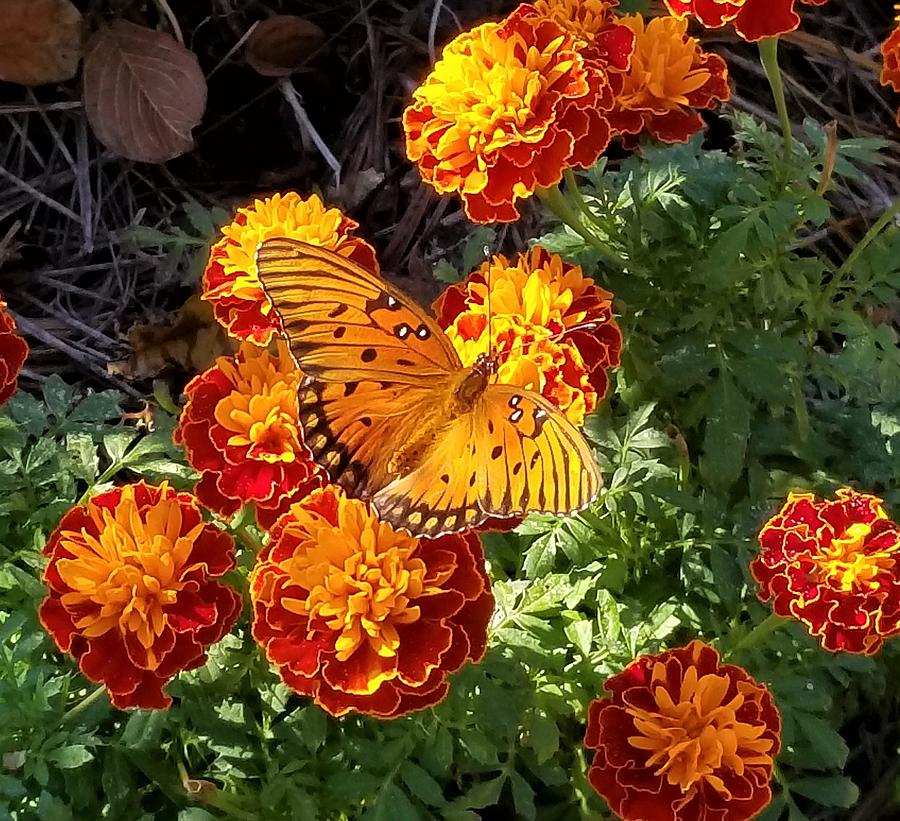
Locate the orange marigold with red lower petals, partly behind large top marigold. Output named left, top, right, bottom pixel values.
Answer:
left=610, top=14, right=730, bottom=143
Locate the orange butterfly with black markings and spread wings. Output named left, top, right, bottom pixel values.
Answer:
left=256, top=239, right=601, bottom=537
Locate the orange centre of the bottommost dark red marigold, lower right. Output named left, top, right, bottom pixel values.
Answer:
left=627, top=662, right=772, bottom=809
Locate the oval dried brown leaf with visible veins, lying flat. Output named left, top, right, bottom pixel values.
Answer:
left=83, top=20, right=206, bottom=162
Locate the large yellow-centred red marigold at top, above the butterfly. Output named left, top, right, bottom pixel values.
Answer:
left=403, top=5, right=613, bottom=222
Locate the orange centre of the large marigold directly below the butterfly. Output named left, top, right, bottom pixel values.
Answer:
left=282, top=503, right=446, bottom=668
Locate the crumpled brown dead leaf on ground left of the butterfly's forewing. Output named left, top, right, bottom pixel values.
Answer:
left=106, top=295, right=234, bottom=379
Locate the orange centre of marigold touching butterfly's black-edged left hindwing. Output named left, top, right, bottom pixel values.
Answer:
left=215, top=343, right=301, bottom=462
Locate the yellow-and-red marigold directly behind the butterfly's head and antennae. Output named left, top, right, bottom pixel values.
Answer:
left=434, top=245, right=622, bottom=425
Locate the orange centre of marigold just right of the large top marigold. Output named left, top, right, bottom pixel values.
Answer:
left=619, top=14, right=711, bottom=113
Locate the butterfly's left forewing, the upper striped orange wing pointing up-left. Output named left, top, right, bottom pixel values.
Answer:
left=257, top=239, right=462, bottom=385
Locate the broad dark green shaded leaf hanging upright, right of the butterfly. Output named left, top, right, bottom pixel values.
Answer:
left=700, top=370, right=750, bottom=493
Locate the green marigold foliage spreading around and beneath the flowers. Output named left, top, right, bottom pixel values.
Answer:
left=0, top=116, right=900, bottom=821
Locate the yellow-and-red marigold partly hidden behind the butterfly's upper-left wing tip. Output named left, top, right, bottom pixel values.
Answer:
left=203, top=191, right=378, bottom=346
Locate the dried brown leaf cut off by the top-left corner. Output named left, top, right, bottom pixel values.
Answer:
left=0, top=0, right=82, bottom=86
